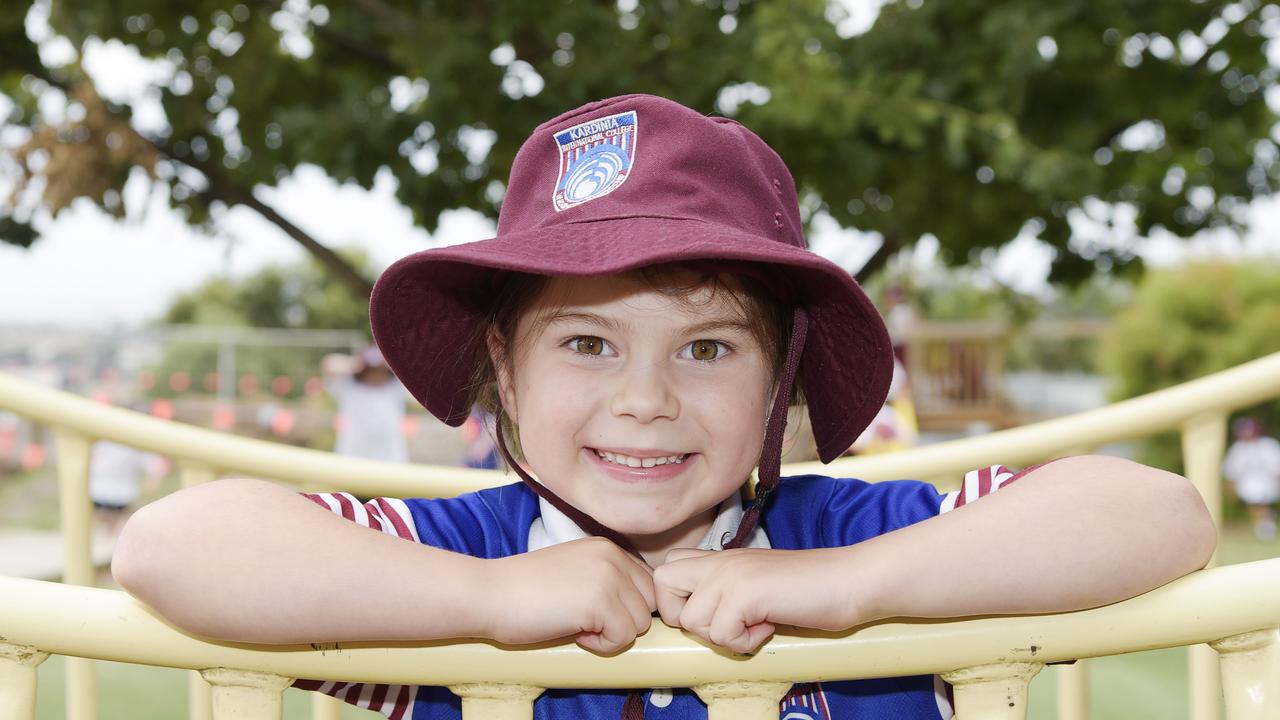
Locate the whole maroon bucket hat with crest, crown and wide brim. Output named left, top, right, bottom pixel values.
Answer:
left=370, top=95, right=892, bottom=462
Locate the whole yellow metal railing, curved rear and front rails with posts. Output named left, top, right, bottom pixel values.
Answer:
left=0, top=345, right=1280, bottom=720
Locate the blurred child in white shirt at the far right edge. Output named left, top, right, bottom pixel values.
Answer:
left=1222, top=418, right=1280, bottom=539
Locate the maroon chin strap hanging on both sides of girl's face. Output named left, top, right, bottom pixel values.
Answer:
left=494, top=307, right=809, bottom=560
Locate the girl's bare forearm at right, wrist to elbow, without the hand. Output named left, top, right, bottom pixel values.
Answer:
left=842, top=456, right=1216, bottom=619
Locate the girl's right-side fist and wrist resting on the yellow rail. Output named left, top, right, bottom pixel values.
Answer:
left=653, top=548, right=870, bottom=653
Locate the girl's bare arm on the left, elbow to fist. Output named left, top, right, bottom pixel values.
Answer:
left=111, top=479, right=654, bottom=652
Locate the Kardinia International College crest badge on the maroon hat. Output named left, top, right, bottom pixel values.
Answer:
left=552, top=110, right=636, bottom=213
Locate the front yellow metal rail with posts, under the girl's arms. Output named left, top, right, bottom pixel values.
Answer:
left=0, top=559, right=1280, bottom=720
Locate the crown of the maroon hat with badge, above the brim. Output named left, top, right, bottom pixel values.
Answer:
left=498, top=95, right=805, bottom=247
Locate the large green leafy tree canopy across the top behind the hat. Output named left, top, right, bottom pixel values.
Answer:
left=0, top=0, right=1280, bottom=292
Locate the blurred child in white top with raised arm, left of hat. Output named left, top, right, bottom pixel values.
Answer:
left=321, top=347, right=408, bottom=462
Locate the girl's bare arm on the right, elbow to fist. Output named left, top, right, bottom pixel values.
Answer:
left=654, top=456, right=1217, bottom=652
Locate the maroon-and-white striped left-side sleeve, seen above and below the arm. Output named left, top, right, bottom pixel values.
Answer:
left=293, top=492, right=419, bottom=720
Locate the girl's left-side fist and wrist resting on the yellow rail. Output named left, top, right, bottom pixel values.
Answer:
left=481, top=538, right=657, bottom=655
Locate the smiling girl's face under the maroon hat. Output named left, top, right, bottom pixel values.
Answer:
left=493, top=275, right=773, bottom=557
